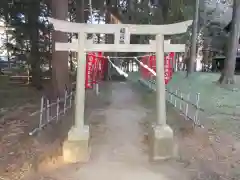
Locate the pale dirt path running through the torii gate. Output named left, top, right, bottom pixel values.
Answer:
left=31, top=83, right=190, bottom=180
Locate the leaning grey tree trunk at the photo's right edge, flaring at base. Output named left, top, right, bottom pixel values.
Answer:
left=219, top=0, right=240, bottom=84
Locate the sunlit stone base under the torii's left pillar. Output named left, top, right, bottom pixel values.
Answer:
left=63, top=126, right=90, bottom=163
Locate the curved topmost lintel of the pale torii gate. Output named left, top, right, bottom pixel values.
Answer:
left=48, top=18, right=192, bottom=35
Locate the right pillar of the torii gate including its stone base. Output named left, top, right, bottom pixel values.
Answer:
left=149, top=34, right=175, bottom=161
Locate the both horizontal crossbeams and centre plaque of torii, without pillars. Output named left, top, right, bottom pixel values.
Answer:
left=49, top=18, right=192, bottom=52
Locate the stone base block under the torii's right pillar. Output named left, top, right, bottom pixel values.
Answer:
left=149, top=125, right=177, bottom=161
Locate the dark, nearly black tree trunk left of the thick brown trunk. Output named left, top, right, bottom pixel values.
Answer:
left=28, top=1, right=42, bottom=89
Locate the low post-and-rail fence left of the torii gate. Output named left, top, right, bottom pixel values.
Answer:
left=29, top=91, right=74, bottom=136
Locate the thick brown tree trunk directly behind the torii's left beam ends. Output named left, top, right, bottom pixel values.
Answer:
left=52, top=0, right=70, bottom=97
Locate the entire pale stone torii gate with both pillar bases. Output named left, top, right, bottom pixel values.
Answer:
left=49, top=18, right=192, bottom=163
